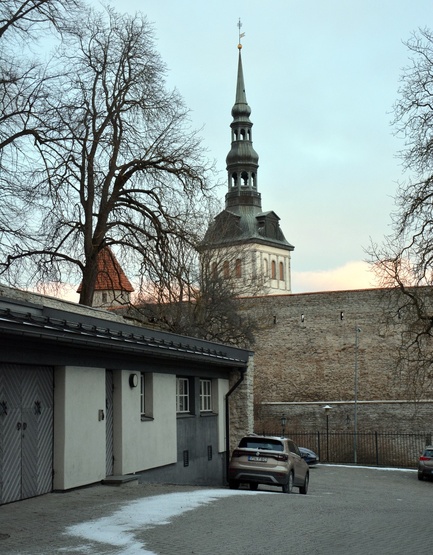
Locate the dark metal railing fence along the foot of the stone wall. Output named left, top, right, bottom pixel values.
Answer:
left=268, top=430, right=433, bottom=468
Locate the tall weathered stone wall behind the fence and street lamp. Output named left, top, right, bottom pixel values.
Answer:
left=240, top=289, right=433, bottom=433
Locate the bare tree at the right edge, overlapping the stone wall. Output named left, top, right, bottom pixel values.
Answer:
left=370, top=29, right=433, bottom=397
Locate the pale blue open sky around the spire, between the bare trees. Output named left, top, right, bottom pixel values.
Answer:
left=95, top=0, right=433, bottom=293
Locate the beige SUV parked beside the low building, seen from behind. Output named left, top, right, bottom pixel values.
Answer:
left=228, top=435, right=310, bottom=494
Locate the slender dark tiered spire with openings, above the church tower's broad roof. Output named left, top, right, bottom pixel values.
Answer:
left=226, top=20, right=261, bottom=212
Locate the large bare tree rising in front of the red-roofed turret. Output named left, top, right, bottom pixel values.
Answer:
left=3, top=4, right=216, bottom=305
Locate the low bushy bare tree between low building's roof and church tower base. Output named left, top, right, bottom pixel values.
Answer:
left=125, top=208, right=266, bottom=348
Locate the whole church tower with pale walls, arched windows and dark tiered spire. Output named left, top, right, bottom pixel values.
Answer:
left=200, top=27, right=294, bottom=296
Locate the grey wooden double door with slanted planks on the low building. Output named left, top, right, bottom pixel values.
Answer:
left=0, top=364, right=53, bottom=504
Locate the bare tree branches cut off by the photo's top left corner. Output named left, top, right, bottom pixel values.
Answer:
left=0, top=0, right=80, bottom=252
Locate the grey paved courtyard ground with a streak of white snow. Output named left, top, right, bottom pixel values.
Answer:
left=0, top=465, right=433, bottom=555
